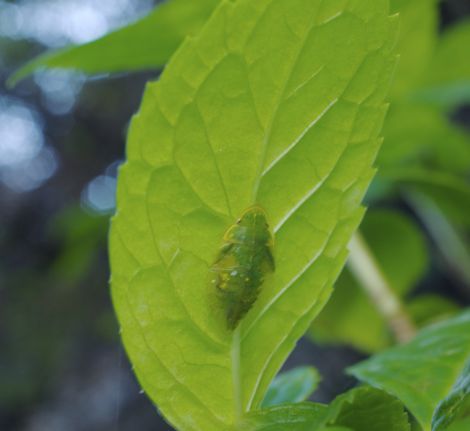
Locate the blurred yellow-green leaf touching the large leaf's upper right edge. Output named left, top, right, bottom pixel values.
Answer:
left=391, top=0, right=439, bottom=100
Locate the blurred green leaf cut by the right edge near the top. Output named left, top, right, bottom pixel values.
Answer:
left=414, top=19, right=470, bottom=109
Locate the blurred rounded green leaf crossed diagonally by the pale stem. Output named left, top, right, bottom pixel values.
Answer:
left=310, top=210, right=428, bottom=353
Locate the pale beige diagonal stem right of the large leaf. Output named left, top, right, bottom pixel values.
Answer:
left=348, top=232, right=416, bottom=343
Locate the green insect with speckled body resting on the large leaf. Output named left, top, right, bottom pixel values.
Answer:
left=211, top=206, right=275, bottom=330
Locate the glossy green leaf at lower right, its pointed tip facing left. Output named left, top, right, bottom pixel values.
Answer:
left=349, top=311, right=470, bottom=431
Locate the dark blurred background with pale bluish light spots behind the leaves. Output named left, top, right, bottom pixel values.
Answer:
left=0, top=0, right=470, bottom=431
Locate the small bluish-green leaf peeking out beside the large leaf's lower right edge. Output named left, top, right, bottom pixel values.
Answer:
left=261, top=367, right=321, bottom=408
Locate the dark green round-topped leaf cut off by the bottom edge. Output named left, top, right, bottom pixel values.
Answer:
left=326, top=387, right=410, bottom=431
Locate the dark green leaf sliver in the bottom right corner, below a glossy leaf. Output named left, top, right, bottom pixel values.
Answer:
left=432, top=362, right=470, bottom=431
